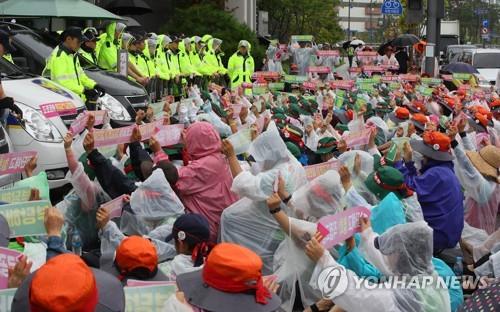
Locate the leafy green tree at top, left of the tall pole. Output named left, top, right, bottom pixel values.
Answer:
left=257, top=0, right=344, bottom=43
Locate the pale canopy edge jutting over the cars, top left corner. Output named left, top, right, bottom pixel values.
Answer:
left=0, top=0, right=121, bottom=20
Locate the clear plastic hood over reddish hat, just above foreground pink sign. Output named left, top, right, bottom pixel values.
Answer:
left=289, top=170, right=345, bottom=222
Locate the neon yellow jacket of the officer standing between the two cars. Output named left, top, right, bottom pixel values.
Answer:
left=42, top=44, right=96, bottom=101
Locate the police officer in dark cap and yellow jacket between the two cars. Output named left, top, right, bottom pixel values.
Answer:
left=43, top=27, right=104, bottom=108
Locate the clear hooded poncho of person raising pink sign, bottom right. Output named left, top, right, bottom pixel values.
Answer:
left=311, top=221, right=451, bottom=312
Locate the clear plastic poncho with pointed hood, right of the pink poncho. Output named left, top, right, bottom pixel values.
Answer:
left=220, top=123, right=306, bottom=274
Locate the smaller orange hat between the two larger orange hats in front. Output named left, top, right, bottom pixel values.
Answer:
left=115, top=236, right=158, bottom=276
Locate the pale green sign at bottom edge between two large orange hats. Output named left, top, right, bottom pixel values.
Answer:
left=123, top=285, right=177, bottom=312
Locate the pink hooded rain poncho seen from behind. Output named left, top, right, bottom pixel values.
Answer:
left=176, top=122, right=238, bottom=241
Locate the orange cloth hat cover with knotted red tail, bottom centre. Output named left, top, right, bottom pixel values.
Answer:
left=203, top=243, right=271, bottom=304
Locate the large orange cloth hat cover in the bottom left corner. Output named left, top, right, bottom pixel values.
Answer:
left=29, top=253, right=99, bottom=312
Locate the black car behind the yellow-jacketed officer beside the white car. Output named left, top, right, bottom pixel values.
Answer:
left=7, top=23, right=149, bottom=127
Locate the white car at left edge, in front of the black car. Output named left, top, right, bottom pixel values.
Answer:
left=0, top=60, right=85, bottom=189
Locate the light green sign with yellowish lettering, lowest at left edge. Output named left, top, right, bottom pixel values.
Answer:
left=0, top=200, right=52, bottom=237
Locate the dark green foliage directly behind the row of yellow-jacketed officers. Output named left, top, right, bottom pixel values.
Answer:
left=161, top=2, right=265, bottom=70
